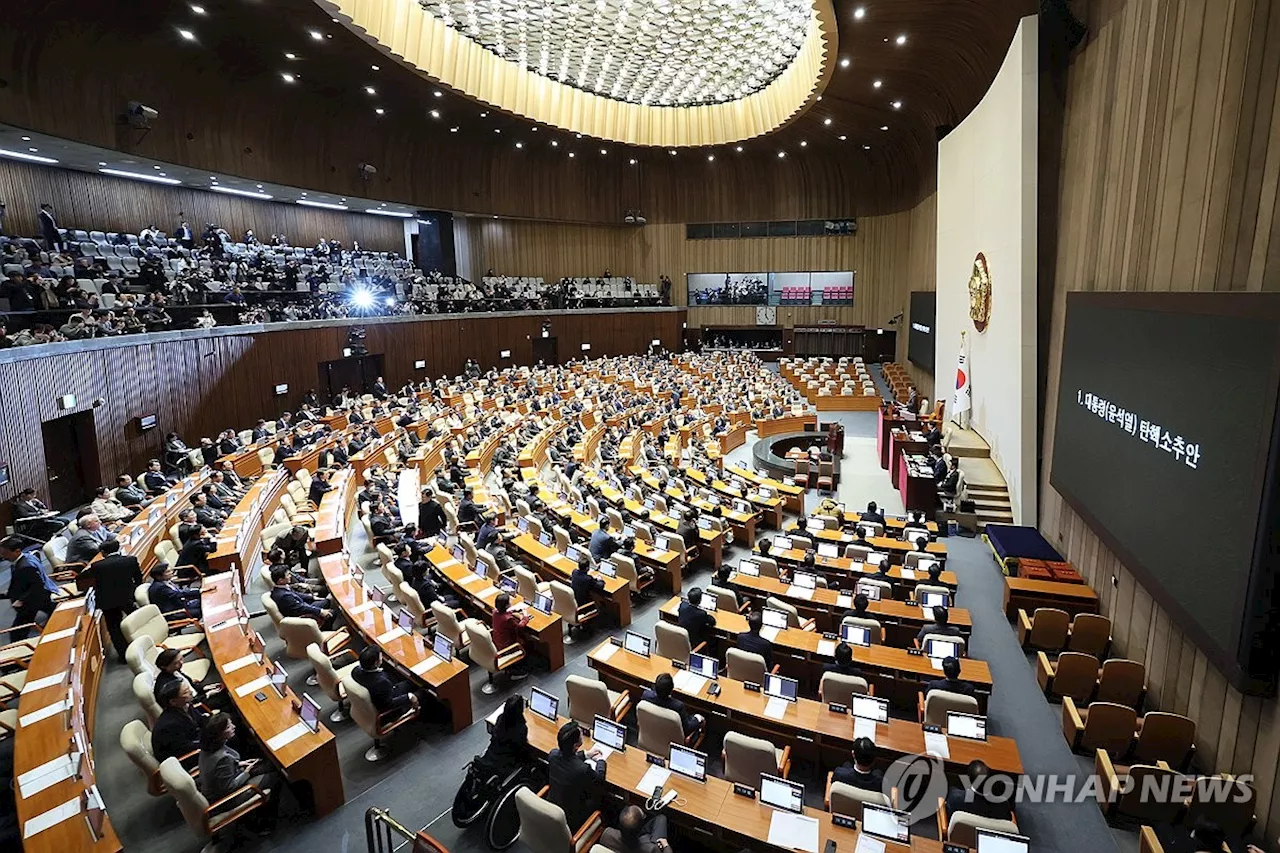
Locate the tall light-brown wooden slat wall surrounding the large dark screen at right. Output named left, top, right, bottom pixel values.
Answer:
left=1041, top=0, right=1280, bottom=838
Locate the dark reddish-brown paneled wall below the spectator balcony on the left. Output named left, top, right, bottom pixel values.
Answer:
left=0, top=310, right=684, bottom=523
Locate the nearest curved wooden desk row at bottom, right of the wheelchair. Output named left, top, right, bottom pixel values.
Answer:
left=506, top=708, right=942, bottom=853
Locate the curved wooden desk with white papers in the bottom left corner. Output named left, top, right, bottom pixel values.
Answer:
left=13, top=598, right=124, bottom=853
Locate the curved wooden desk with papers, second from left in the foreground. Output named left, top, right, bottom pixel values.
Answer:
left=200, top=573, right=347, bottom=816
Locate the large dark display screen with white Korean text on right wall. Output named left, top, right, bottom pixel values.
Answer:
left=1050, top=293, right=1280, bottom=686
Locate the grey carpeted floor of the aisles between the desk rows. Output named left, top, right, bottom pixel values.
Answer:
left=0, top=373, right=1137, bottom=853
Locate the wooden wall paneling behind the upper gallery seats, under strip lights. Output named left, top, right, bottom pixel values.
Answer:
left=0, top=160, right=404, bottom=255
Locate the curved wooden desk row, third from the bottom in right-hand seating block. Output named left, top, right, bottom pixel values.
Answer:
left=660, top=598, right=992, bottom=710
